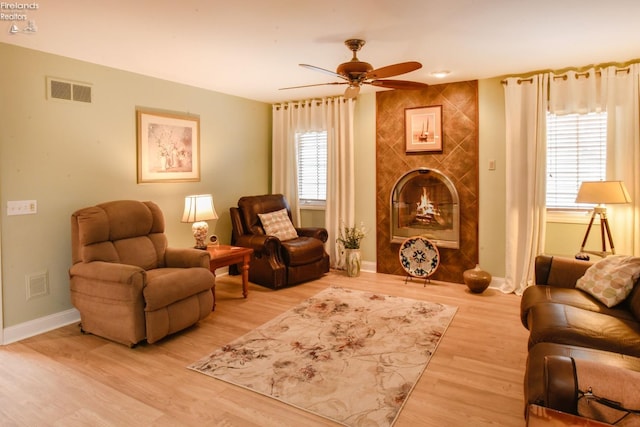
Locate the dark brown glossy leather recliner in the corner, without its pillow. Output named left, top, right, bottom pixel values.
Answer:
left=229, top=194, right=329, bottom=289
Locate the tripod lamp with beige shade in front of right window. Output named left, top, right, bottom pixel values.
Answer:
left=576, top=181, right=631, bottom=259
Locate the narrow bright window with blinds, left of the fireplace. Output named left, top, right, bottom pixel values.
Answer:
left=296, top=132, right=327, bottom=205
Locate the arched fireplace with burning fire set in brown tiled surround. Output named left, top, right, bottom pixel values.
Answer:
left=390, top=168, right=460, bottom=249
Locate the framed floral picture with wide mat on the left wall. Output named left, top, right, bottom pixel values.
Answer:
left=136, top=108, right=200, bottom=183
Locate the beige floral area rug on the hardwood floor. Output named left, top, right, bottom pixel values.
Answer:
left=189, top=287, right=457, bottom=426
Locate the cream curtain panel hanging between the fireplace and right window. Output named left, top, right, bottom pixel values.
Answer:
left=500, top=74, right=549, bottom=295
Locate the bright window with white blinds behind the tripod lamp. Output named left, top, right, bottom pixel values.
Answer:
left=547, top=112, right=607, bottom=211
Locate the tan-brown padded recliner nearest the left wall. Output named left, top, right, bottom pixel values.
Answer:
left=69, top=200, right=215, bottom=347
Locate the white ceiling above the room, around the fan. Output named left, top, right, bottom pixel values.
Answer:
left=0, top=0, right=640, bottom=102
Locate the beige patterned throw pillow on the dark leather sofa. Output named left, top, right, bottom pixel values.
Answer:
left=576, top=255, right=640, bottom=307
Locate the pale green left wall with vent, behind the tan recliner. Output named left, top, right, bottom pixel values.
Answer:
left=0, top=43, right=271, bottom=328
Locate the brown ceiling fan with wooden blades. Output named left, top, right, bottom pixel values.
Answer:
left=281, top=39, right=428, bottom=98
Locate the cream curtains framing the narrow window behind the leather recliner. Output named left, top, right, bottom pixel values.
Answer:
left=272, top=97, right=355, bottom=267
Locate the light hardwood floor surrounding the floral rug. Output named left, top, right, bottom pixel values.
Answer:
left=0, top=272, right=527, bottom=427
